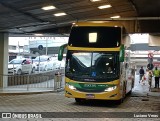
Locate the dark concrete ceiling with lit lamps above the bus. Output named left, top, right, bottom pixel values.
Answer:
left=0, top=0, right=160, bottom=35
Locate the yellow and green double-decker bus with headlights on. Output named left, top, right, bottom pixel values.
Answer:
left=58, top=22, right=134, bottom=102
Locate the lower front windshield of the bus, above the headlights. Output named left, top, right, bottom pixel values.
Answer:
left=65, top=51, right=119, bottom=82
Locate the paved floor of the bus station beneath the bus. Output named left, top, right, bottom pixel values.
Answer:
left=0, top=77, right=160, bottom=121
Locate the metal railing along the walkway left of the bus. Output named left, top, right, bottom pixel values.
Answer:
left=0, top=69, right=64, bottom=93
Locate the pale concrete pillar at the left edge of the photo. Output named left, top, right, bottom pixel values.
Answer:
left=0, top=33, right=8, bottom=88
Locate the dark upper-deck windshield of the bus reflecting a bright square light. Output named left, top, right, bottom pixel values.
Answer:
left=68, top=26, right=121, bottom=48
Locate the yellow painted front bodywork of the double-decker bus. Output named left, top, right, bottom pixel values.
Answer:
left=65, top=21, right=123, bottom=100
